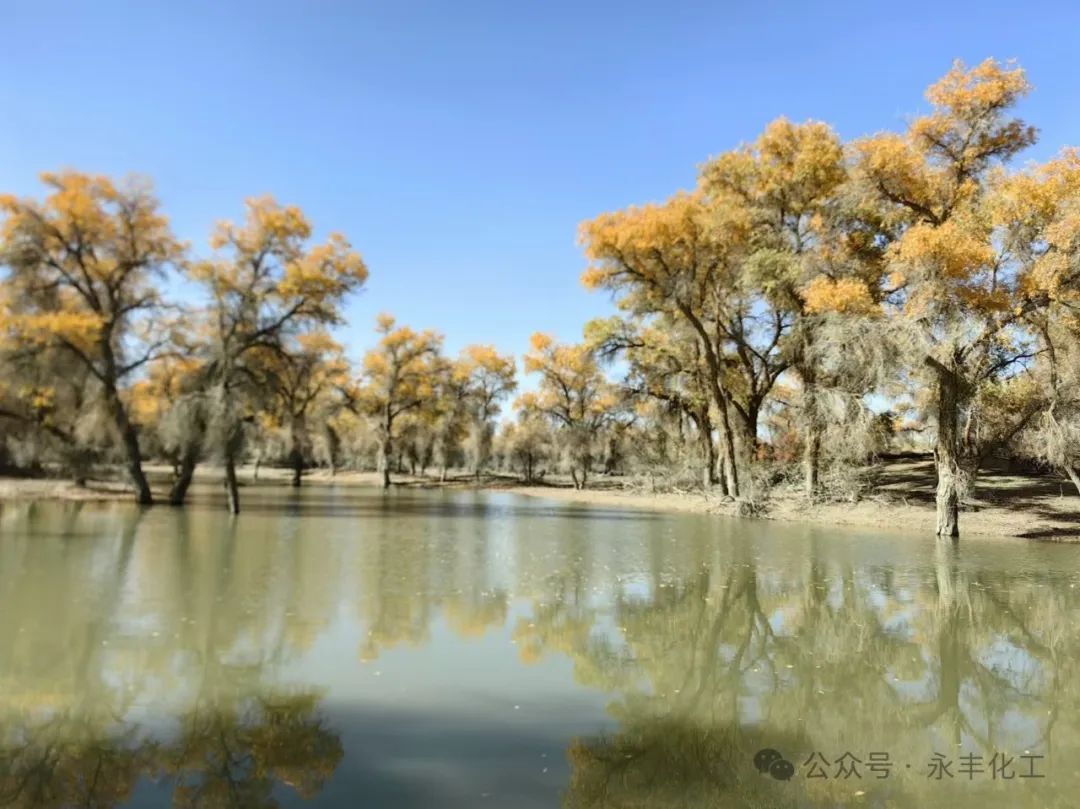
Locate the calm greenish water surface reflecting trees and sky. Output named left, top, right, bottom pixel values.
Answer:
left=0, top=488, right=1080, bottom=809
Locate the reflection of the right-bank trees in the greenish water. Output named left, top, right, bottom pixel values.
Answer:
left=516, top=527, right=1080, bottom=809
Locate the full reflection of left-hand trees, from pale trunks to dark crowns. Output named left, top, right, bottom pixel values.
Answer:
left=0, top=507, right=342, bottom=809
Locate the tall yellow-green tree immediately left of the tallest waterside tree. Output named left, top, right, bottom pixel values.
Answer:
left=699, top=118, right=894, bottom=499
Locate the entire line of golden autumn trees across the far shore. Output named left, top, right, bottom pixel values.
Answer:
left=0, top=60, right=1080, bottom=536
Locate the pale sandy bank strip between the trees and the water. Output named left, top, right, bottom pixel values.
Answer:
left=6, top=460, right=1080, bottom=542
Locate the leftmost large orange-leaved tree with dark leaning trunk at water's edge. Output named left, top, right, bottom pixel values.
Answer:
left=0, top=172, right=184, bottom=504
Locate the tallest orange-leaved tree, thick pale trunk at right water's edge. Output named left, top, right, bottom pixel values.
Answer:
left=853, top=59, right=1054, bottom=537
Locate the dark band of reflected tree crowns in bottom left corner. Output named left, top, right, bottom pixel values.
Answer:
left=0, top=695, right=342, bottom=809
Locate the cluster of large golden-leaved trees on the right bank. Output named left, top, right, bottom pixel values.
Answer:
left=581, top=60, right=1080, bottom=536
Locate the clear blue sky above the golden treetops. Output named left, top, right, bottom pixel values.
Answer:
left=0, top=0, right=1080, bottom=365
